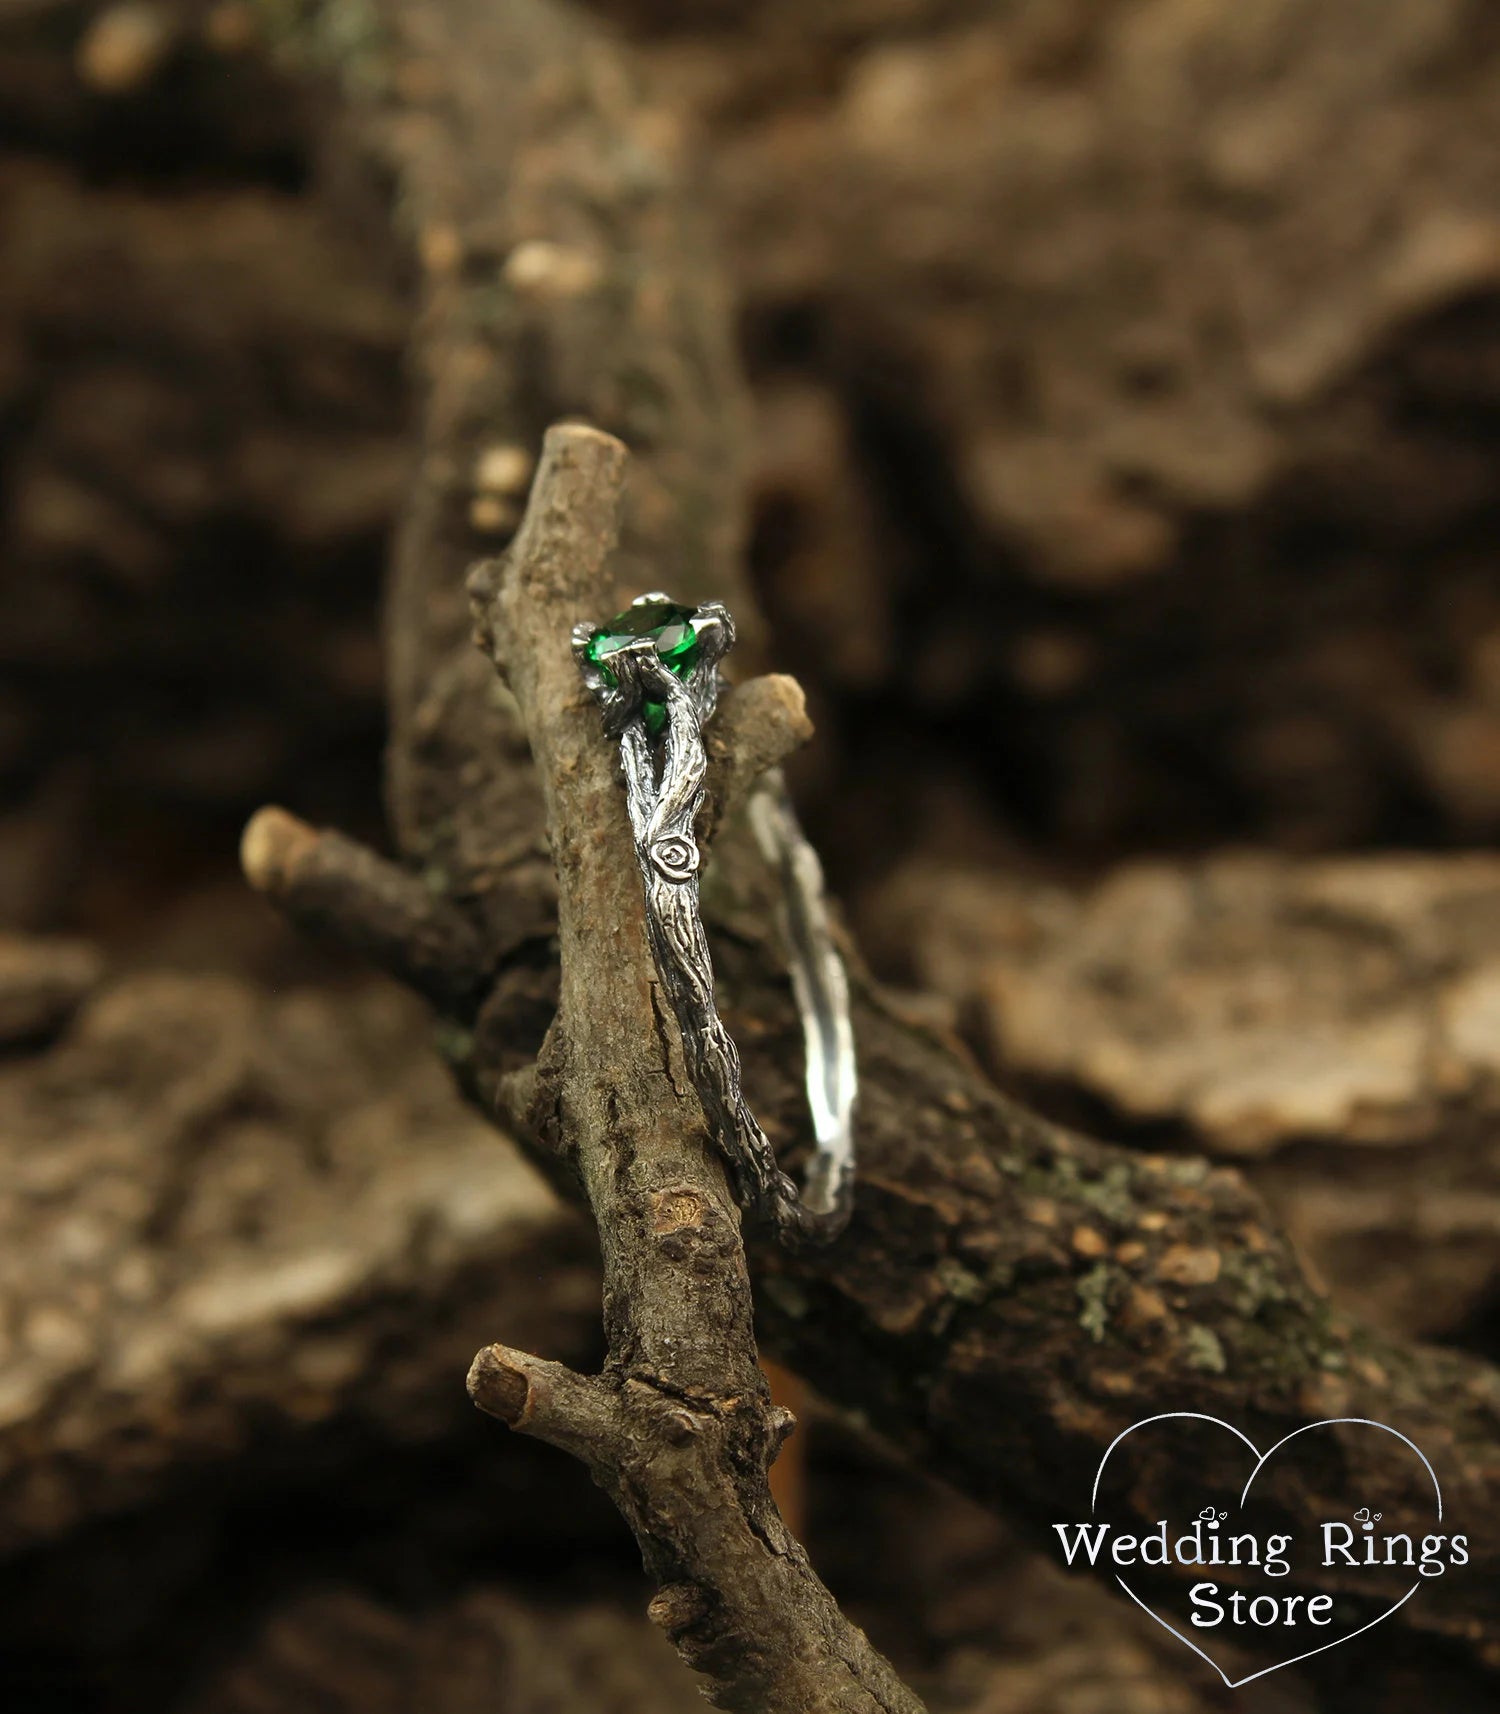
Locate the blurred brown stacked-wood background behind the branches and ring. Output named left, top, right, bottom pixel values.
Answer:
left=0, top=0, right=1500, bottom=1714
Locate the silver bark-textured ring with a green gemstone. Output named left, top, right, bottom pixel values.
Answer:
left=573, top=593, right=855, bottom=1244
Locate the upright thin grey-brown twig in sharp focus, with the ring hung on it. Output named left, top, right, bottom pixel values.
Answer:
left=470, top=425, right=921, bottom=1714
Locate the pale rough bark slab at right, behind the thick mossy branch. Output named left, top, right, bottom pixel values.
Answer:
left=862, top=852, right=1500, bottom=1342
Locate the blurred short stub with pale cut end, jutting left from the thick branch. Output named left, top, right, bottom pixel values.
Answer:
left=240, top=806, right=485, bottom=1003
